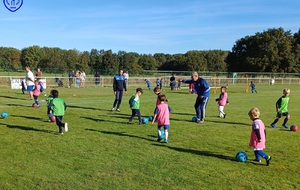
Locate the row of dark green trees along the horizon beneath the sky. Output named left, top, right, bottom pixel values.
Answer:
left=0, top=28, right=300, bottom=75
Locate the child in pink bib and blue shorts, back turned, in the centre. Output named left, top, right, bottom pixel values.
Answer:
left=152, top=94, right=171, bottom=143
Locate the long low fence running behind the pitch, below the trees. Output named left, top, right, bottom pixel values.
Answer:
left=0, top=76, right=300, bottom=88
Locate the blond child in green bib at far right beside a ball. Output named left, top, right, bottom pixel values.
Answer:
left=271, top=88, right=291, bottom=128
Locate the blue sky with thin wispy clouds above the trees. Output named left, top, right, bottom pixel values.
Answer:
left=0, top=0, right=300, bottom=54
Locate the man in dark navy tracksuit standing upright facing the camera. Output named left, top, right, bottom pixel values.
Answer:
left=111, top=69, right=127, bottom=112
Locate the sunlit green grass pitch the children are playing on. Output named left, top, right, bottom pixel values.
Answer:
left=0, top=85, right=300, bottom=189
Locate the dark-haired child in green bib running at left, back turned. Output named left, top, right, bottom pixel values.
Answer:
left=48, top=90, right=68, bottom=135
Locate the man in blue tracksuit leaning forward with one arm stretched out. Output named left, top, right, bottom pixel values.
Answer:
left=182, top=72, right=210, bottom=123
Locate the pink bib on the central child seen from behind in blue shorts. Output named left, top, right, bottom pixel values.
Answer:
left=154, top=103, right=170, bottom=125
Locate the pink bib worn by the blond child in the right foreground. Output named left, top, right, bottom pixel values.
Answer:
left=249, top=119, right=266, bottom=148
